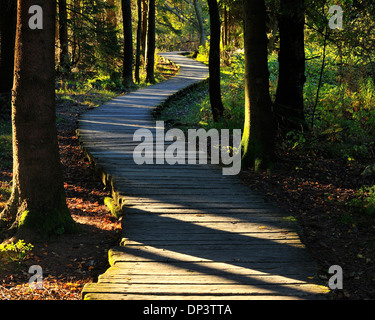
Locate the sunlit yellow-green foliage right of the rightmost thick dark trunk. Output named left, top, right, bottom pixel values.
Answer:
left=304, top=43, right=375, bottom=158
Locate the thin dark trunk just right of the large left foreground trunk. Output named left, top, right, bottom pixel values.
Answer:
left=59, top=0, right=70, bottom=73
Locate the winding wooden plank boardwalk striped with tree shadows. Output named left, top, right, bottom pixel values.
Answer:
left=79, top=53, right=327, bottom=300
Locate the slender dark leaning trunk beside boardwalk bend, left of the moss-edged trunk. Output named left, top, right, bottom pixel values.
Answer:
left=208, top=0, right=224, bottom=122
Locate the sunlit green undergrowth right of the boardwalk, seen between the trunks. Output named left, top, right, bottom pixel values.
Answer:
left=157, top=42, right=375, bottom=218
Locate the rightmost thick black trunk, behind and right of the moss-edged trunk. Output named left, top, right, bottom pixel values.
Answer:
left=275, top=0, right=307, bottom=135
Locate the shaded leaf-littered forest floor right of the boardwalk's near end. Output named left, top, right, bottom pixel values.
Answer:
left=240, top=155, right=375, bottom=300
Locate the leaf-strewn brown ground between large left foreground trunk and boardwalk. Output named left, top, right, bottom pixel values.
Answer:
left=0, top=102, right=121, bottom=300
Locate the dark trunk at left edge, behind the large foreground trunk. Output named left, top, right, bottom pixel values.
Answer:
left=0, top=0, right=17, bottom=94
